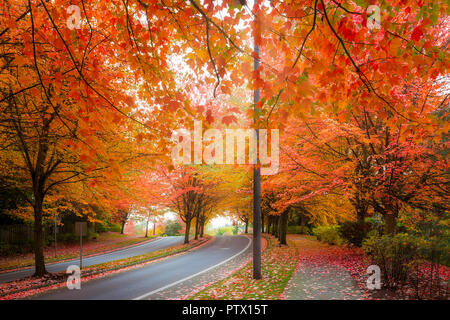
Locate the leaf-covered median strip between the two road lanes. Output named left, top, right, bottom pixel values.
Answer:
left=0, top=237, right=211, bottom=300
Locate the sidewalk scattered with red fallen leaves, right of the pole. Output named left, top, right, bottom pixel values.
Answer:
left=283, top=235, right=366, bottom=300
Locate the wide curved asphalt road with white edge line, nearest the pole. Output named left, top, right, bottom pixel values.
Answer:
left=31, top=236, right=251, bottom=300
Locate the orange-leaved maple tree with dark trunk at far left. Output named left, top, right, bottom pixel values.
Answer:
left=0, top=1, right=179, bottom=275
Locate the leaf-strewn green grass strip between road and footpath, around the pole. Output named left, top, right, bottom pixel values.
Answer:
left=191, top=236, right=298, bottom=300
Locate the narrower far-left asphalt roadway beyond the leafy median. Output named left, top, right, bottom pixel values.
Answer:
left=0, top=236, right=183, bottom=283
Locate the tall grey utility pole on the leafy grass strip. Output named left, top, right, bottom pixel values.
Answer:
left=253, top=0, right=262, bottom=279
